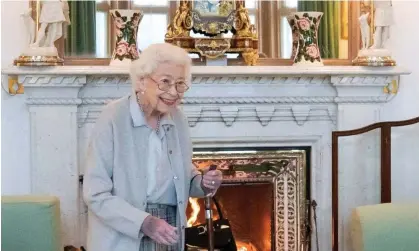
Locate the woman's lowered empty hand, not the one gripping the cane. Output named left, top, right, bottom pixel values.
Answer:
left=141, top=215, right=179, bottom=246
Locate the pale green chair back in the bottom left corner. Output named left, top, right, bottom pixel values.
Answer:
left=1, top=196, right=62, bottom=251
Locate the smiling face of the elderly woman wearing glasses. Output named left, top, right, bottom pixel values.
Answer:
left=136, top=63, right=187, bottom=113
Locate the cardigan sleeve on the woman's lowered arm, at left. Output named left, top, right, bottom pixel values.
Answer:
left=83, top=111, right=149, bottom=239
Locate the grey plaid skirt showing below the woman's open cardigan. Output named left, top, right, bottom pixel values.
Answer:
left=140, top=204, right=181, bottom=251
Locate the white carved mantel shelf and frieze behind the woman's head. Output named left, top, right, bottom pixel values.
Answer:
left=3, top=66, right=408, bottom=127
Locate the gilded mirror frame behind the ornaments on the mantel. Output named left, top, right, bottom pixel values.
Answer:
left=29, top=0, right=374, bottom=66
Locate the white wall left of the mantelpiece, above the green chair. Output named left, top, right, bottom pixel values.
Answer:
left=0, top=0, right=30, bottom=194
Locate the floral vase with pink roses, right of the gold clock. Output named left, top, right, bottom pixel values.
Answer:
left=287, top=11, right=323, bottom=66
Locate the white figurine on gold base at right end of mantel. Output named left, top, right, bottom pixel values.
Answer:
left=352, top=0, right=396, bottom=66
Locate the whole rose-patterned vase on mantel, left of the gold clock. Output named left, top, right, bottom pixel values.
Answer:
left=109, top=9, right=144, bottom=66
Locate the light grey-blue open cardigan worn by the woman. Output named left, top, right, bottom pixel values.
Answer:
left=83, top=96, right=204, bottom=251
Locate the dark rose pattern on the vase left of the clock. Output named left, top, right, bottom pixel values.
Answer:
left=111, top=10, right=142, bottom=61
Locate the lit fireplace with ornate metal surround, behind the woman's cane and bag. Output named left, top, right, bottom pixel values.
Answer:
left=186, top=147, right=310, bottom=251
